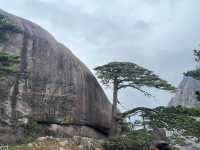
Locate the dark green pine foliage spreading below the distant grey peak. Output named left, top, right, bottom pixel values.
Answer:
left=146, top=106, right=200, bottom=139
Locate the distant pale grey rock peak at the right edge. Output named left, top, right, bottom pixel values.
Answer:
left=169, top=77, right=200, bottom=108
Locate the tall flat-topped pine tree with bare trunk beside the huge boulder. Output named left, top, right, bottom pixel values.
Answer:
left=95, top=62, right=175, bottom=135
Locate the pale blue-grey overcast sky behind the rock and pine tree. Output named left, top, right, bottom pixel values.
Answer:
left=0, top=0, right=200, bottom=108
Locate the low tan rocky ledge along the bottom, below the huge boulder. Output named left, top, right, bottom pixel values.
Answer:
left=8, top=136, right=104, bottom=150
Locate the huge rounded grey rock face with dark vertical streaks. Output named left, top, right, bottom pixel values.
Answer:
left=0, top=10, right=111, bottom=139
